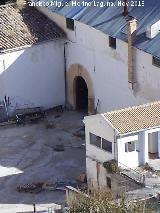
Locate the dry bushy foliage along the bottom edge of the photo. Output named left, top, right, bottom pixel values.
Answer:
left=69, top=190, right=155, bottom=213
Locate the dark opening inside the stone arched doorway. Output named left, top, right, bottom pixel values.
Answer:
left=76, top=76, right=88, bottom=111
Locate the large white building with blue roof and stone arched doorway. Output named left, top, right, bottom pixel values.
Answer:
left=35, top=0, right=160, bottom=113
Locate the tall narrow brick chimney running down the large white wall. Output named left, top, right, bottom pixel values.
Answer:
left=128, top=18, right=137, bottom=89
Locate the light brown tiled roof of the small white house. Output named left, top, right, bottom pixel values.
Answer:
left=104, top=101, right=160, bottom=134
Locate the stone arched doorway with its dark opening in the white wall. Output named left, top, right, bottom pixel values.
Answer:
left=67, top=64, right=95, bottom=114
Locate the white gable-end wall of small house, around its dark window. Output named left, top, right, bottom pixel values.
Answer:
left=84, top=114, right=115, bottom=188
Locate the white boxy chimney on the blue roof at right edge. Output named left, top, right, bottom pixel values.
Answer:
left=146, top=20, right=160, bottom=39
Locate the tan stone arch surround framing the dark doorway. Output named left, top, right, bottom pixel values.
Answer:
left=66, top=64, right=95, bottom=114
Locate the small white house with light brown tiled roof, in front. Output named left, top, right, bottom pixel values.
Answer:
left=84, top=102, right=160, bottom=190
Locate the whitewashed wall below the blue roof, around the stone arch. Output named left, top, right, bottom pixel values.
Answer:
left=37, top=7, right=160, bottom=112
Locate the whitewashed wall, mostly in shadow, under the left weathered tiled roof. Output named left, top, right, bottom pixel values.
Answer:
left=0, top=41, right=65, bottom=108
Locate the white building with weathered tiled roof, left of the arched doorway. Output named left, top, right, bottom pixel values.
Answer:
left=0, top=5, right=65, bottom=115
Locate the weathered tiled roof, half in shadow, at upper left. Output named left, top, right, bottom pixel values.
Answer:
left=0, top=5, right=65, bottom=52
